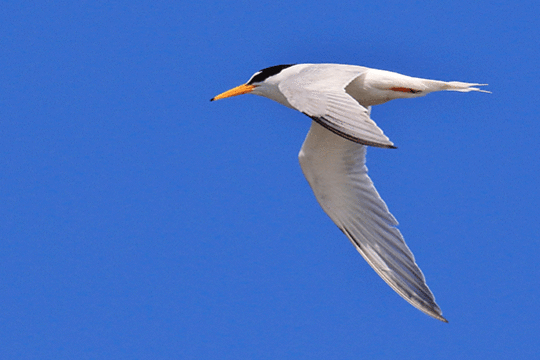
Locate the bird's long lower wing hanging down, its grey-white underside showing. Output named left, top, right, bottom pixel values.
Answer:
left=299, top=122, right=446, bottom=322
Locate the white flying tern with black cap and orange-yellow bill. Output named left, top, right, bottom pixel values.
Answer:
left=210, top=64, right=490, bottom=322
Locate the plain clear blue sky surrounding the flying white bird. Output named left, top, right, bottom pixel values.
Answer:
left=0, top=1, right=540, bottom=359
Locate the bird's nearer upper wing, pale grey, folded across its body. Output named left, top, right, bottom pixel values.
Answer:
left=279, top=65, right=394, bottom=148
